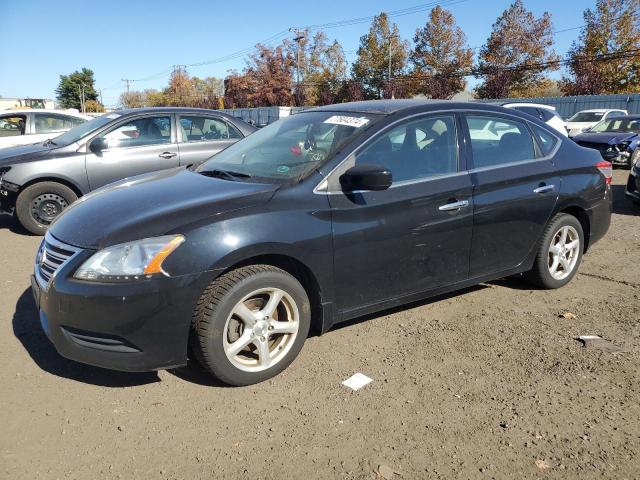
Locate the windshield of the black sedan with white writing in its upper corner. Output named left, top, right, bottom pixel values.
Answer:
left=197, top=112, right=380, bottom=183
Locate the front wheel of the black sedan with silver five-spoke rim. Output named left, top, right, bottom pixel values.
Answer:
left=190, top=265, right=311, bottom=386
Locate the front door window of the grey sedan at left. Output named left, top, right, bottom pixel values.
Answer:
left=102, top=116, right=171, bottom=149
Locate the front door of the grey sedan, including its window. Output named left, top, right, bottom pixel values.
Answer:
left=86, top=113, right=179, bottom=190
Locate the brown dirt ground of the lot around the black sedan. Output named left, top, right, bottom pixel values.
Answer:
left=0, top=170, right=640, bottom=480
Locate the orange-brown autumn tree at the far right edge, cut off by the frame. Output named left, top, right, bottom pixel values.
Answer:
left=561, top=0, right=640, bottom=95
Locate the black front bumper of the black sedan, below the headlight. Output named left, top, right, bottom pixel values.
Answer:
left=31, top=244, right=207, bottom=372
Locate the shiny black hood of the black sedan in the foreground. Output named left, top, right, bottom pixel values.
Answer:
left=49, top=168, right=278, bottom=249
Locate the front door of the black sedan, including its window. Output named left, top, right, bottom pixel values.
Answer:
left=329, top=114, right=473, bottom=314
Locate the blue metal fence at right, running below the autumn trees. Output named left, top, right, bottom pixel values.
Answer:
left=476, top=93, right=640, bottom=118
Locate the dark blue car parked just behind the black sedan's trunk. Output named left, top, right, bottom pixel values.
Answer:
left=573, top=115, right=640, bottom=168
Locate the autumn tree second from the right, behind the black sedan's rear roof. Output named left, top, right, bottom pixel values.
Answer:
left=476, top=0, right=559, bottom=98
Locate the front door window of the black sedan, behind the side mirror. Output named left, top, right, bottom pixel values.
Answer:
left=355, top=115, right=458, bottom=184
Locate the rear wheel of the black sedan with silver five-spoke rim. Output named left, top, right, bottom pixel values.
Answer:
left=525, top=213, right=584, bottom=289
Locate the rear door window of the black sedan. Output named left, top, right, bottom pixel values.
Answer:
left=465, top=115, right=535, bottom=168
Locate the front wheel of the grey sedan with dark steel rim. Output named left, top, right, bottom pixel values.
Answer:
left=16, top=182, right=78, bottom=235
